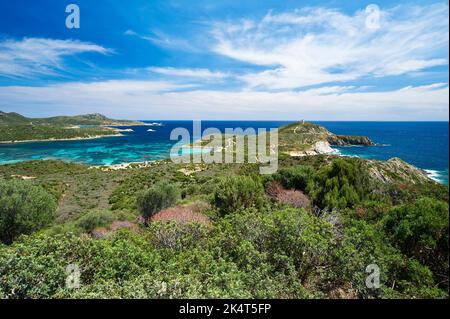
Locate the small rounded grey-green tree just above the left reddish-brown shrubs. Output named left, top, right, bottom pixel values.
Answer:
left=137, top=182, right=180, bottom=223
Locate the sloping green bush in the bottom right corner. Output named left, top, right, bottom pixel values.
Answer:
left=329, top=220, right=447, bottom=298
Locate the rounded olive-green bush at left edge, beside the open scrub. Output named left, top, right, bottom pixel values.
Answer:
left=0, top=180, right=56, bottom=244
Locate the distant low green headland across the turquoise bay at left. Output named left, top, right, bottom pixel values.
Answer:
left=0, top=111, right=145, bottom=143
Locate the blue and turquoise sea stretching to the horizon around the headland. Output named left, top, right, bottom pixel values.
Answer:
left=0, top=120, right=449, bottom=185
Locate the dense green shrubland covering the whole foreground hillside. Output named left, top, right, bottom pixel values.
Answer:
left=0, top=156, right=449, bottom=298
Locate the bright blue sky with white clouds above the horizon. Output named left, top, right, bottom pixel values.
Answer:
left=0, top=0, right=449, bottom=120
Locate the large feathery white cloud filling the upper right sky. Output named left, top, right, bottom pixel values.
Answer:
left=212, top=4, right=448, bottom=89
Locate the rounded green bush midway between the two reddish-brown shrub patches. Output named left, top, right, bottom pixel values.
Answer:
left=213, top=176, right=265, bottom=216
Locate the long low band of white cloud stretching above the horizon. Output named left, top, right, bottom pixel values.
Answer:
left=0, top=81, right=449, bottom=120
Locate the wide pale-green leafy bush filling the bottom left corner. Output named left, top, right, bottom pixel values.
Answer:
left=0, top=230, right=161, bottom=299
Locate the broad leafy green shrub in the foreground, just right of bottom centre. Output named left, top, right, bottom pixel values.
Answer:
left=211, top=208, right=334, bottom=283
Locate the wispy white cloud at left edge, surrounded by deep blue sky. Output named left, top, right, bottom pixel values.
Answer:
left=0, top=38, right=111, bottom=77
